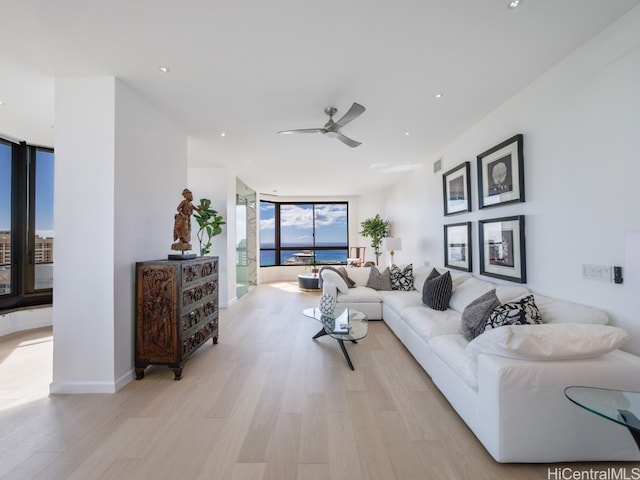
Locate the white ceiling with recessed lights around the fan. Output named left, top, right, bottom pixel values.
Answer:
left=0, top=0, right=640, bottom=195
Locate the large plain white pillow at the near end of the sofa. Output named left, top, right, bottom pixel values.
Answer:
left=466, top=323, right=629, bottom=361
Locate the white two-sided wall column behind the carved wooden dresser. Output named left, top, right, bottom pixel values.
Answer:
left=50, top=77, right=187, bottom=393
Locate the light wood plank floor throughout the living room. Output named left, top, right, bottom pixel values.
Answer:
left=0, top=283, right=632, bottom=480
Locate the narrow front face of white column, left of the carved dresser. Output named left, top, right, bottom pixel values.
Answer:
left=50, top=77, right=115, bottom=393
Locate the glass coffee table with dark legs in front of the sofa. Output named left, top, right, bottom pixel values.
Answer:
left=302, top=307, right=369, bottom=370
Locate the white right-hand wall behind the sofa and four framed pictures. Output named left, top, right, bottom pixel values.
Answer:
left=363, top=7, right=640, bottom=354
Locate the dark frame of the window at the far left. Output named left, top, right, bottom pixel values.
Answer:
left=0, top=137, right=55, bottom=312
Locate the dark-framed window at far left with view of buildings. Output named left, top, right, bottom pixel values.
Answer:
left=0, top=139, right=54, bottom=310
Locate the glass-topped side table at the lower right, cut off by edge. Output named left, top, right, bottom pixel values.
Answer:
left=564, top=386, right=640, bottom=448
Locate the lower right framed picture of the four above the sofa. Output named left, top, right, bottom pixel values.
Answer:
left=478, top=215, right=527, bottom=283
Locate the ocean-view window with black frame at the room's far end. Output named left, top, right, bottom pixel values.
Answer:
left=260, top=201, right=349, bottom=267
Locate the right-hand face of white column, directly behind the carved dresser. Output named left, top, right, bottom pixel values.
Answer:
left=114, top=80, right=187, bottom=385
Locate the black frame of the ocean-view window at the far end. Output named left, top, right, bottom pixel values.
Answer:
left=259, top=200, right=349, bottom=268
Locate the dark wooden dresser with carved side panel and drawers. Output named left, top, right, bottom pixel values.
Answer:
left=135, top=257, right=218, bottom=380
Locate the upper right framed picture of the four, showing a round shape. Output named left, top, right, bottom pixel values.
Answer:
left=478, top=134, right=524, bottom=208
